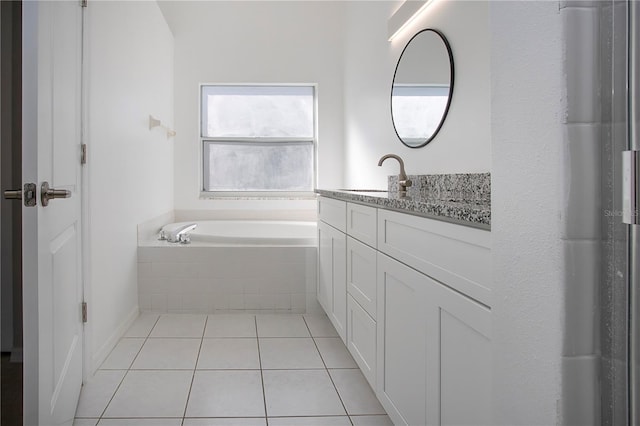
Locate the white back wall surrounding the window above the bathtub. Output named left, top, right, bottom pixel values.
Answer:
left=160, top=1, right=345, bottom=210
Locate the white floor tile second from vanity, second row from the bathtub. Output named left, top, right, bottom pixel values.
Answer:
left=260, top=338, right=324, bottom=370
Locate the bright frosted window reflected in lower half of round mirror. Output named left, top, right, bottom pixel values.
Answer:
left=391, top=87, right=449, bottom=142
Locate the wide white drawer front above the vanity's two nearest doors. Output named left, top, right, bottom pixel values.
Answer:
left=378, top=210, right=491, bottom=306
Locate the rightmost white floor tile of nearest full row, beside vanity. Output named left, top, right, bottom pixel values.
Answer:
left=329, top=369, right=387, bottom=415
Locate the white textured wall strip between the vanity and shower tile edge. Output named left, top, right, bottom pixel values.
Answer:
left=490, top=1, right=566, bottom=425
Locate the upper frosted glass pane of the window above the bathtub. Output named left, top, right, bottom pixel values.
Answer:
left=202, top=86, right=314, bottom=139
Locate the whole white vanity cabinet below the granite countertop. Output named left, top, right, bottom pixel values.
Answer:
left=318, top=197, right=492, bottom=425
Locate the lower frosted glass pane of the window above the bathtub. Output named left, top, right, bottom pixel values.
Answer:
left=204, top=141, right=313, bottom=191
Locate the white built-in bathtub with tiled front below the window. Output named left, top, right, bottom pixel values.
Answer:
left=138, top=220, right=320, bottom=313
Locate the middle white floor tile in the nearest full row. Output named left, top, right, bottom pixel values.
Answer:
left=186, top=370, right=265, bottom=417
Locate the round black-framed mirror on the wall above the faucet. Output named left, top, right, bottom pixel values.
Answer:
left=391, top=29, right=454, bottom=148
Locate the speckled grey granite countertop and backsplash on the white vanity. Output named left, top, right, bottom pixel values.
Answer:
left=316, top=173, right=491, bottom=229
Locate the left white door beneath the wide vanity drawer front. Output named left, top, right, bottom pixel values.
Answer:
left=377, top=253, right=429, bottom=425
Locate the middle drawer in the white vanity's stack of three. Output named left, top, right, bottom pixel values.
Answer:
left=347, top=237, right=377, bottom=319
